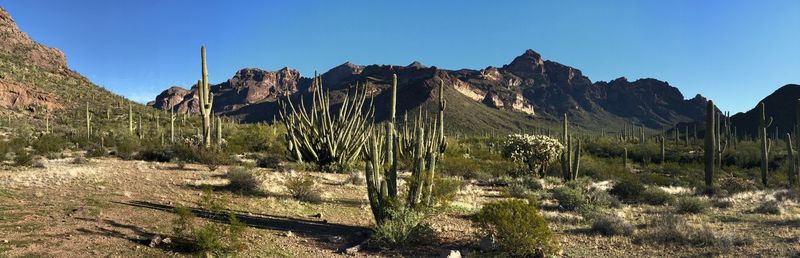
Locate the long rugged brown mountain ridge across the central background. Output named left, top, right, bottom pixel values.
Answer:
left=150, top=50, right=705, bottom=132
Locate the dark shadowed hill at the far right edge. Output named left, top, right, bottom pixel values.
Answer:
left=731, top=84, right=800, bottom=137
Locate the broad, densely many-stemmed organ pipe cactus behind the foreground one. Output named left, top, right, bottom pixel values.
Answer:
left=278, top=71, right=374, bottom=167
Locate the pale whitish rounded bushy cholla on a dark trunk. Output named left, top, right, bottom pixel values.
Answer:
left=503, top=134, right=564, bottom=177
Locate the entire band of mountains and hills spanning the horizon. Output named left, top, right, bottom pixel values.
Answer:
left=0, top=5, right=800, bottom=134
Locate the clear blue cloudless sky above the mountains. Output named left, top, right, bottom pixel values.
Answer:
left=0, top=0, right=800, bottom=112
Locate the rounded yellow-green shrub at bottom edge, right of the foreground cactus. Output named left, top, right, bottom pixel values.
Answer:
left=474, top=200, right=559, bottom=257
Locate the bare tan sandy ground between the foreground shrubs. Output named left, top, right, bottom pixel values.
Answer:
left=0, top=158, right=800, bottom=257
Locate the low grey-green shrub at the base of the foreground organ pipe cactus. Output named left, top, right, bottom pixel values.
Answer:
left=367, top=208, right=434, bottom=248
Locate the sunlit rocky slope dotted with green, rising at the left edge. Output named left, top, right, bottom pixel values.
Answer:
left=0, top=8, right=146, bottom=129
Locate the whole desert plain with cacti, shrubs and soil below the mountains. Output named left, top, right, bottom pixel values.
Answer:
left=0, top=45, right=800, bottom=257
